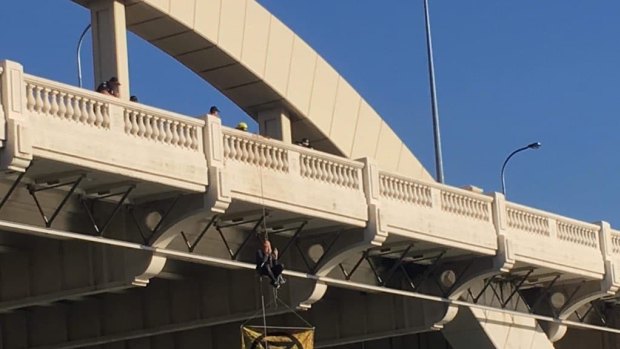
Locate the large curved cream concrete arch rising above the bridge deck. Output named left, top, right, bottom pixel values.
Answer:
left=73, top=0, right=432, bottom=180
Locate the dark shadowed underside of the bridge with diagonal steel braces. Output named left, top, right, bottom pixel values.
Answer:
left=0, top=176, right=617, bottom=349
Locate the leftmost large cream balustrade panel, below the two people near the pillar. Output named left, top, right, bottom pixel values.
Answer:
left=24, top=74, right=208, bottom=191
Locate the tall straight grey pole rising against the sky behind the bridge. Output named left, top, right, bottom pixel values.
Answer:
left=424, top=0, right=444, bottom=183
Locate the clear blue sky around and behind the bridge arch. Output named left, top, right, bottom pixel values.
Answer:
left=0, top=0, right=620, bottom=227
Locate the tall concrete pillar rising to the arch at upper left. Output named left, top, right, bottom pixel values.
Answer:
left=89, top=0, right=130, bottom=100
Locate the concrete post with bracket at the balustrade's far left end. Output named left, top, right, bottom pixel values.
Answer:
left=0, top=61, right=32, bottom=172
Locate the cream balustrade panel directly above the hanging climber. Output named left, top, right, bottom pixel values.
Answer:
left=222, top=128, right=368, bottom=226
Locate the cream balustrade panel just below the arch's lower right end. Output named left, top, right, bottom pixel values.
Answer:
left=379, top=171, right=497, bottom=255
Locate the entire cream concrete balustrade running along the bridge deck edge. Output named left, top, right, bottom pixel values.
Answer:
left=0, top=62, right=620, bottom=285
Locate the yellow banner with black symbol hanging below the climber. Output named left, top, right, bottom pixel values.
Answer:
left=241, top=326, right=314, bottom=349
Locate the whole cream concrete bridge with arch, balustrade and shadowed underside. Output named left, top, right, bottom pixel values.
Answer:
left=0, top=0, right=620, bottom=349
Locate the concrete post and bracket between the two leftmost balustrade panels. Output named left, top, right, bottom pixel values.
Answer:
left=203, top=116, right=232, bottom=213
